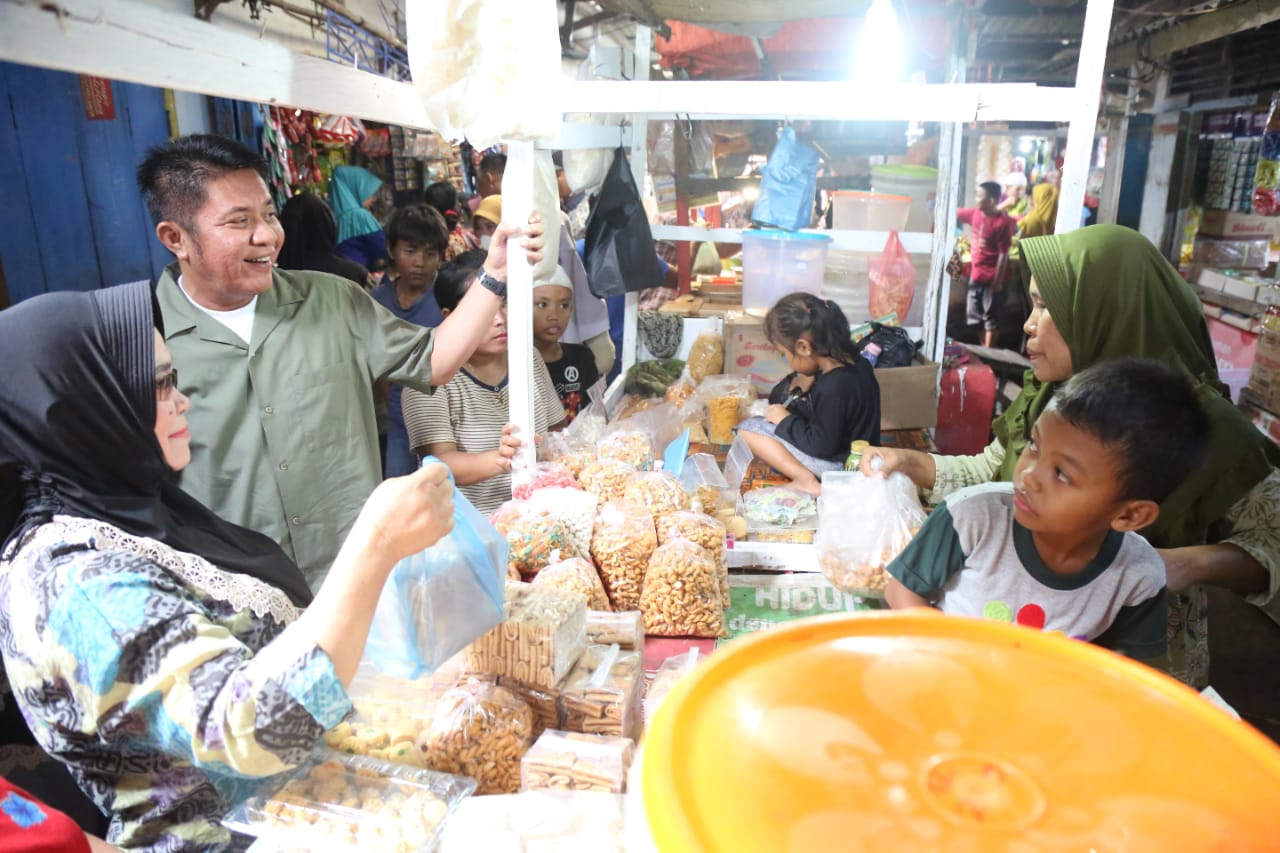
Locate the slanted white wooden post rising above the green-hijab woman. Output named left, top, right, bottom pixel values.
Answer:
left=1053, top=0, right=1115, bottom=234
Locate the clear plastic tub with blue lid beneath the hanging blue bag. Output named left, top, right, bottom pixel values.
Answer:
left=742, top=228, right=831, bottom=316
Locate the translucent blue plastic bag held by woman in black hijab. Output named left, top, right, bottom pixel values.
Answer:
left=364, top=456, right=507, bottom=679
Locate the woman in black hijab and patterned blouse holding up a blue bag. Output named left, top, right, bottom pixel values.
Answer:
left=0, top=284, right=452, bottom=852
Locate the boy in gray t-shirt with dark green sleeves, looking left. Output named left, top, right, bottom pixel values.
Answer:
left=886, top=359, right=1210, bottom=658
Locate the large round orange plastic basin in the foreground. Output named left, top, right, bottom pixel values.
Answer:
left=643, top=611, right=1280, bottom=853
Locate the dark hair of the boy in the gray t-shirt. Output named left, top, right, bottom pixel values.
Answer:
left=1047, top=359, right=1211, bottom=503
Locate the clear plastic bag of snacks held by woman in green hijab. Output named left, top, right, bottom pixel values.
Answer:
left=814, top=471, right=924, bottom=597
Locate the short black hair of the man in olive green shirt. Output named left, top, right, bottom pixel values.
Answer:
left=137, top=133, right=270, bottom=229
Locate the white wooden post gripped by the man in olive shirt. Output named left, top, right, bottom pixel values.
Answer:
left=502, top=142, right=537, bottom=466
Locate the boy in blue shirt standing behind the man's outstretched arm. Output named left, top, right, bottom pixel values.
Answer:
left=372, top=205, right=449, bottom=476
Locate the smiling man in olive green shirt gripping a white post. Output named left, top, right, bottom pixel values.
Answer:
left=138, top=136, right=541, bottom=589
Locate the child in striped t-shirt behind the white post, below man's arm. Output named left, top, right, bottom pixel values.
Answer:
left=403, top=250, right=564, bottom=514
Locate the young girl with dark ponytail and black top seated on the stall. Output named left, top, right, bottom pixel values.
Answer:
left=739, top=293, right=881, bottom=494
